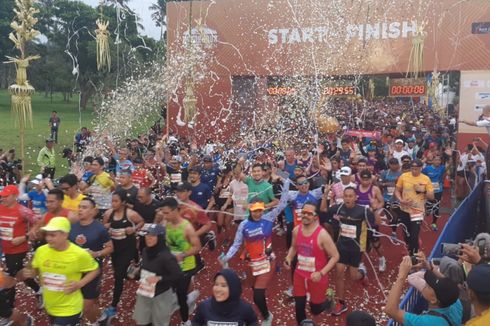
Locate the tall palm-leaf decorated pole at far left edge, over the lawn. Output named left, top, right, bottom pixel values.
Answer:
left=6, top=0, right=40, bottom=171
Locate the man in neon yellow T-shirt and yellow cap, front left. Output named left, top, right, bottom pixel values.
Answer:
left=23, top=217, right=100, bottom=325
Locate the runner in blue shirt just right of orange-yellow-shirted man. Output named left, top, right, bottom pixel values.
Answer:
left=422, top=156, right=446, bottom=231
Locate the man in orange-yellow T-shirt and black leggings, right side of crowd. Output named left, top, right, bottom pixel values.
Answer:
left=395, top=159, right=434, bottom=255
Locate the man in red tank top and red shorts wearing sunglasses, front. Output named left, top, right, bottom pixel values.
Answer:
left=284, top=203, right=340, bottom=324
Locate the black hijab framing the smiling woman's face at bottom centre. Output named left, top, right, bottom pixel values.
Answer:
left=211, top=269, right=242, bottom=316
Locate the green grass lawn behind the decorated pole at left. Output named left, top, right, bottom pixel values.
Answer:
left=0, top=90, right=93, bottom=177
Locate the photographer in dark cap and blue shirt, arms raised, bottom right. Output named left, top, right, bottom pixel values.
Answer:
left=385, top=253, right=463, bottom=326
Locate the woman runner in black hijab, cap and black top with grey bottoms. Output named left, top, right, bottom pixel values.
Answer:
left=133, top=224, right=182, bottom=326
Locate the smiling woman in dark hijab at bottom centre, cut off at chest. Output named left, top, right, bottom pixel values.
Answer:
left=192, top=269, right=257, bottom=326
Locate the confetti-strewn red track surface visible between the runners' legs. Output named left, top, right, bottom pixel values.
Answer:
left=17, top=199, right=447, bottom=326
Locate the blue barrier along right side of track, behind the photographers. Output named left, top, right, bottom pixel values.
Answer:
left=388, top=182, right=486, bottom=326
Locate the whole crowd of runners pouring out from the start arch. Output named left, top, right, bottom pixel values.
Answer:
left=0, top=102, right=486, bottom=325
